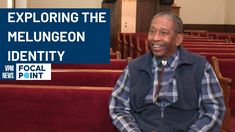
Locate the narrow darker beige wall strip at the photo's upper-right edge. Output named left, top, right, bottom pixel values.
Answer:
left=225, top=0, right=235, bottom=24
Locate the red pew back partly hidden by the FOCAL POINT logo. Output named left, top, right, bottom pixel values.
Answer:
left=0, top=69, right=123, bottom=87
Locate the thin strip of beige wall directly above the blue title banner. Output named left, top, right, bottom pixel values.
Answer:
left=28, top=0, right=102, bottom=8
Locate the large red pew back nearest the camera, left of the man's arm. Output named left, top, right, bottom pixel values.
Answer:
left=0, top=84, right=117, bottom=132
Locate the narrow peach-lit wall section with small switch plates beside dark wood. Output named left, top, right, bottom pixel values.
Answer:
left=121, top=0, right=137, bottom=33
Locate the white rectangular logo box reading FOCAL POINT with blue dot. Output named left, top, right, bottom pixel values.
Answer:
left=16, top=63, right=51, bottom=80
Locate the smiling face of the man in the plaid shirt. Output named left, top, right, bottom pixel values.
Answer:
left=148, top=16, right=181, bottom=58
